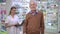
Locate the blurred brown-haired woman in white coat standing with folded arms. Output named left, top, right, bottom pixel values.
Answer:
left=5, top=7, right=20, bottom=34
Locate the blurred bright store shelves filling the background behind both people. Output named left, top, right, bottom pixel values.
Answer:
left=0, top=0, right=60, bottom=34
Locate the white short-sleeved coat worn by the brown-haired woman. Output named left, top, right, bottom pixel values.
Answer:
left=5, top=15, right=20, bottom=34
